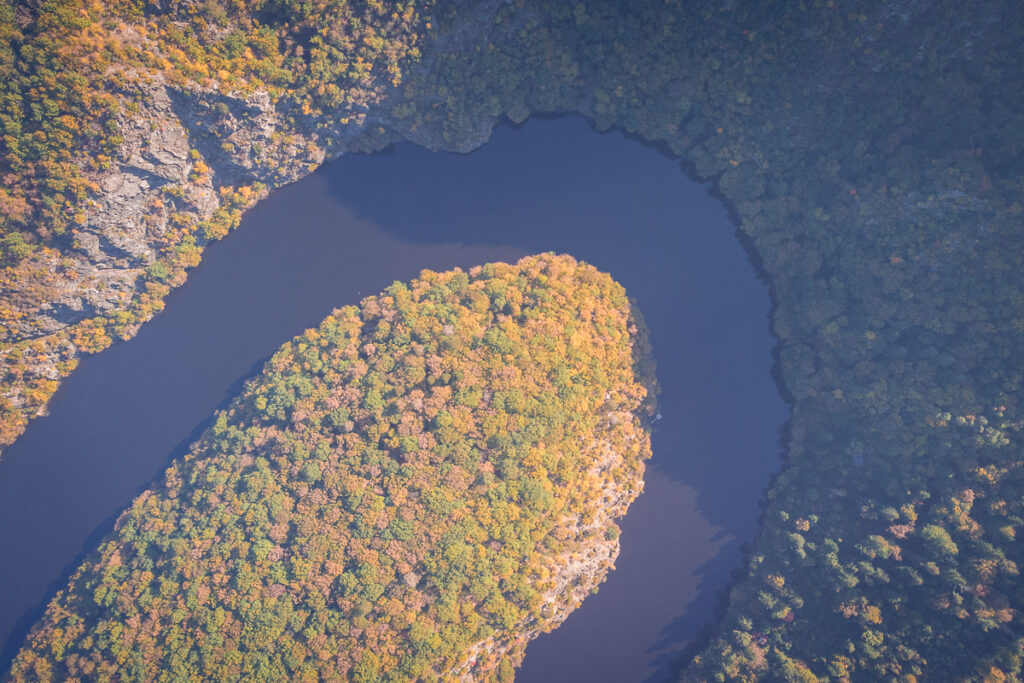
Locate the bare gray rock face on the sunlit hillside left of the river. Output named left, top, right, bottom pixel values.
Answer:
left=0, top=69, right=324, bottom=421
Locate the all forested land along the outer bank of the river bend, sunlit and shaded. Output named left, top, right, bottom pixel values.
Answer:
left=0, top=0, right=1024, bottom=681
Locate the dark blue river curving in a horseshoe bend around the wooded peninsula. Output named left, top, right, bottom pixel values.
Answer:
left=0, top=118, right=788, bottom=682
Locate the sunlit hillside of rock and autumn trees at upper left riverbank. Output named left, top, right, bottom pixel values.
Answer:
left=0, top=1, right=436, bottom=444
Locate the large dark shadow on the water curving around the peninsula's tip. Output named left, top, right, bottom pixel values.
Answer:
left=324, top=117, right=788, bottom=530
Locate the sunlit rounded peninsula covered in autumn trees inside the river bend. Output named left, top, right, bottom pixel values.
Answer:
left=11, top=255, right=654, bottom=681
